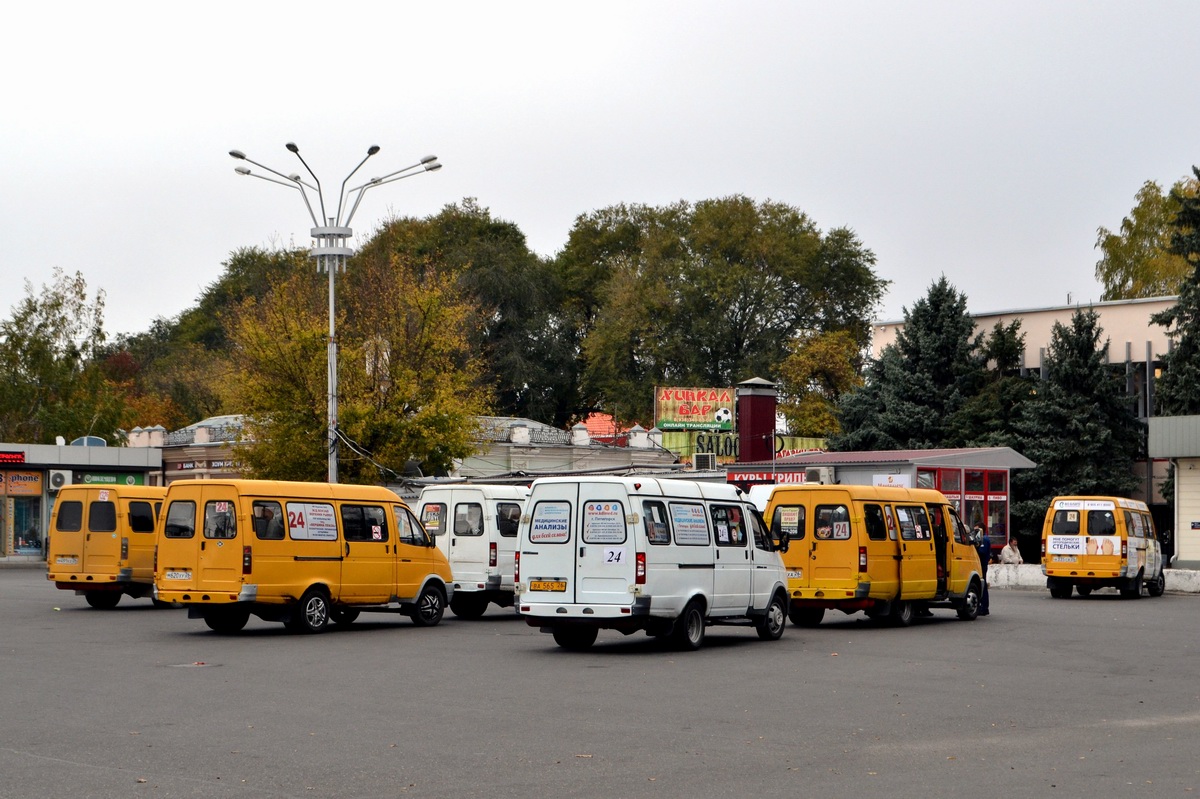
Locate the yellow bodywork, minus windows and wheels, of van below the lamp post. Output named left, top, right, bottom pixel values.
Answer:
left=155, top=480, right=451, bottom=606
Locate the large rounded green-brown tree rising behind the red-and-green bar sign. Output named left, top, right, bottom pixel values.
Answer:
left=557, top=197, right=887, bottom=421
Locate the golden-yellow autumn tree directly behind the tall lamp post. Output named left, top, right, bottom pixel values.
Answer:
left=227, top=247, right=488, bottom=482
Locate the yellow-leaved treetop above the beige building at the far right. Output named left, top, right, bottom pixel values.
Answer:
left=1096, top=179, right=1200, bottom=300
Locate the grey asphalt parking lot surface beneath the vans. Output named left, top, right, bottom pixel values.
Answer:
left=0, top=570, right=1200, bottom=799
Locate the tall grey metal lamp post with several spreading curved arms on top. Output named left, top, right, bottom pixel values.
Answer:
left=229, top=142, right=442, bottom=482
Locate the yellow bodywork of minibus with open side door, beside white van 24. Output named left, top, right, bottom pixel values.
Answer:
left=764, top=485, right=980, bottom=612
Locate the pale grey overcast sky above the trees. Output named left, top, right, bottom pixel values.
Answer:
left=0, top=0, right=1200, bottom=334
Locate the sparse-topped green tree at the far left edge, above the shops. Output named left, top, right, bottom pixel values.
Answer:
left=0, top=268, right=125, bottom=444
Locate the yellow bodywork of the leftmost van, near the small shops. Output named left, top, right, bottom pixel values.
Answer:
left=46, top=485, right=167, bottom=594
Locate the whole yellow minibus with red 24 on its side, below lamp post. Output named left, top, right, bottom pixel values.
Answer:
left=155, top=480, right=454, bottom=633
